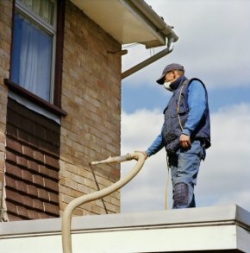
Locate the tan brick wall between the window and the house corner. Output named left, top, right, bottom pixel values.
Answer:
left=59, top=1, right=121, bottom=215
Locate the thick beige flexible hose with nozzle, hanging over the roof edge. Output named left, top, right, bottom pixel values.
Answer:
left=62, top=152, right=145, bottom=253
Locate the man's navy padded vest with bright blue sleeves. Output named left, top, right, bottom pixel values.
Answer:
left=146, top=76, right=211, bottom=156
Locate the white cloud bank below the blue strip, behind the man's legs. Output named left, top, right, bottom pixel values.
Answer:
left=121, top=104, right=250, bottom=212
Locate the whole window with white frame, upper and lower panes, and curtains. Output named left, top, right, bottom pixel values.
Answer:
left=11, top=0, right=57, bottom=103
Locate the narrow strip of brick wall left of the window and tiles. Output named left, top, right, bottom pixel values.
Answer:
left=0, top=0, right=12, bottom=221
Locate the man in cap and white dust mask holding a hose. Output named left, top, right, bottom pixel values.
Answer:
left=144, top=63, right=211, bottom=208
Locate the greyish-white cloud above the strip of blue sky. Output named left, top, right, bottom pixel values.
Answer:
left=123, top=0, right=250, bottom=88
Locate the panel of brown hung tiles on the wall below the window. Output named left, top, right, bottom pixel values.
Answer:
left=5, top=98, right=60, bottom=221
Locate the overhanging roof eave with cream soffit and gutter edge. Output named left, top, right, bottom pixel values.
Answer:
left=71, top=0, right=178, bottom=48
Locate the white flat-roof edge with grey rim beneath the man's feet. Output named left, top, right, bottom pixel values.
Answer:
left=0, top=205, right=250, bottom=253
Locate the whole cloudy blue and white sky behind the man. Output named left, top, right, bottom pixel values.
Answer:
left=121, top=0, right=250, bottom=213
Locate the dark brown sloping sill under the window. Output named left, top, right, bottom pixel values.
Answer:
left=4, top=79, right=67, bottom=116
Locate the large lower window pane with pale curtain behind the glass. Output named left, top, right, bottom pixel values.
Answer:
left=11, top=12, right=53, bottom=101
